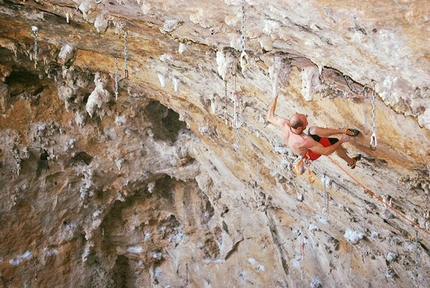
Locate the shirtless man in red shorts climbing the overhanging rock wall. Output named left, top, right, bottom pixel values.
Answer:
left=267, top=96, right=361, bottom=169
